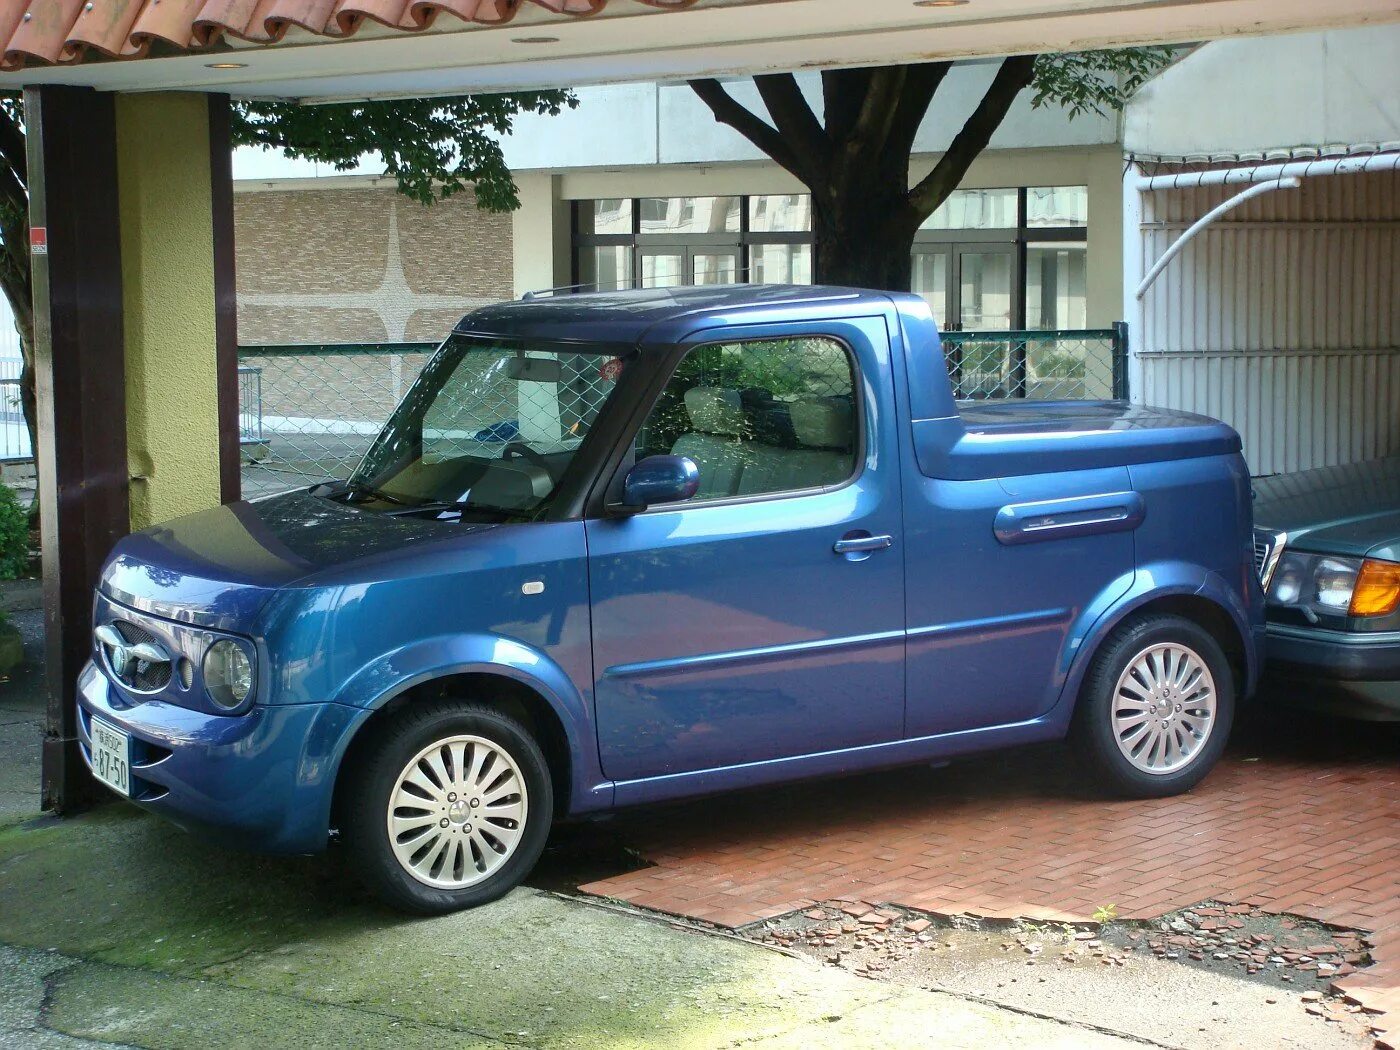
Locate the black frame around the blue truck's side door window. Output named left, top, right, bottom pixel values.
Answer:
left=585, top=330, right=869, bottom=519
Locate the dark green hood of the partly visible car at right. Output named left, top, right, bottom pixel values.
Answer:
left=1254, top=458, right=1400, bottom=561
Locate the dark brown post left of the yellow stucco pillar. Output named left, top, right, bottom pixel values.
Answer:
left=24, top=87, right=130, bottom=812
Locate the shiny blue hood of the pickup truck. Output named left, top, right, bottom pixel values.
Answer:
left=99, top=491, right=493, bottom=630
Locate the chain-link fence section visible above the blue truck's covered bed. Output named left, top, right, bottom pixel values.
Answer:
left=942, top=322, right=1128, bottom=400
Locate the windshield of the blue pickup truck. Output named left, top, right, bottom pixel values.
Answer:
left=342, top=335, right=623, bottom=521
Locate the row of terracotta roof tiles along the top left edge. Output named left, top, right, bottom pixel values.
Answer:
left=0, top=0, right=696, bottom=70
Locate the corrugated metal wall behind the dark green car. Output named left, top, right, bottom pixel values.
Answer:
left=1133, top=172, right=1400, bottom=473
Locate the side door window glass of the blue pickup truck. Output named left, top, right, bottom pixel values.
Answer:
left=637, top=339, right=860, bottom=503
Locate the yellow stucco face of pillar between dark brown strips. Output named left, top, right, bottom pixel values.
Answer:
left=116, top=94, right=218, bottom=529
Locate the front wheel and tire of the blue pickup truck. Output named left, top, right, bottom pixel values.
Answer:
left=344, top=701, right=554, bottom=914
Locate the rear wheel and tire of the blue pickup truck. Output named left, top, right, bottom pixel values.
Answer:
left=1071, top=613, right=1235, bottom=798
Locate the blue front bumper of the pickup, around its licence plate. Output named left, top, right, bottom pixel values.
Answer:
left=77, top=662, right=367, bottom=853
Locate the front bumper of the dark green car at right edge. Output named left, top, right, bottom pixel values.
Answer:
left=1263, top=624, right=1400, bottom=721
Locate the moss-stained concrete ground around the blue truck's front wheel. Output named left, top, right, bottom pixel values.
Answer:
left=0, top=806, right=1148, bottom=1050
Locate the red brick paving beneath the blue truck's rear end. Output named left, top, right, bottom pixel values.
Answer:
left=582, top=710, right=1400, bottom=1037
